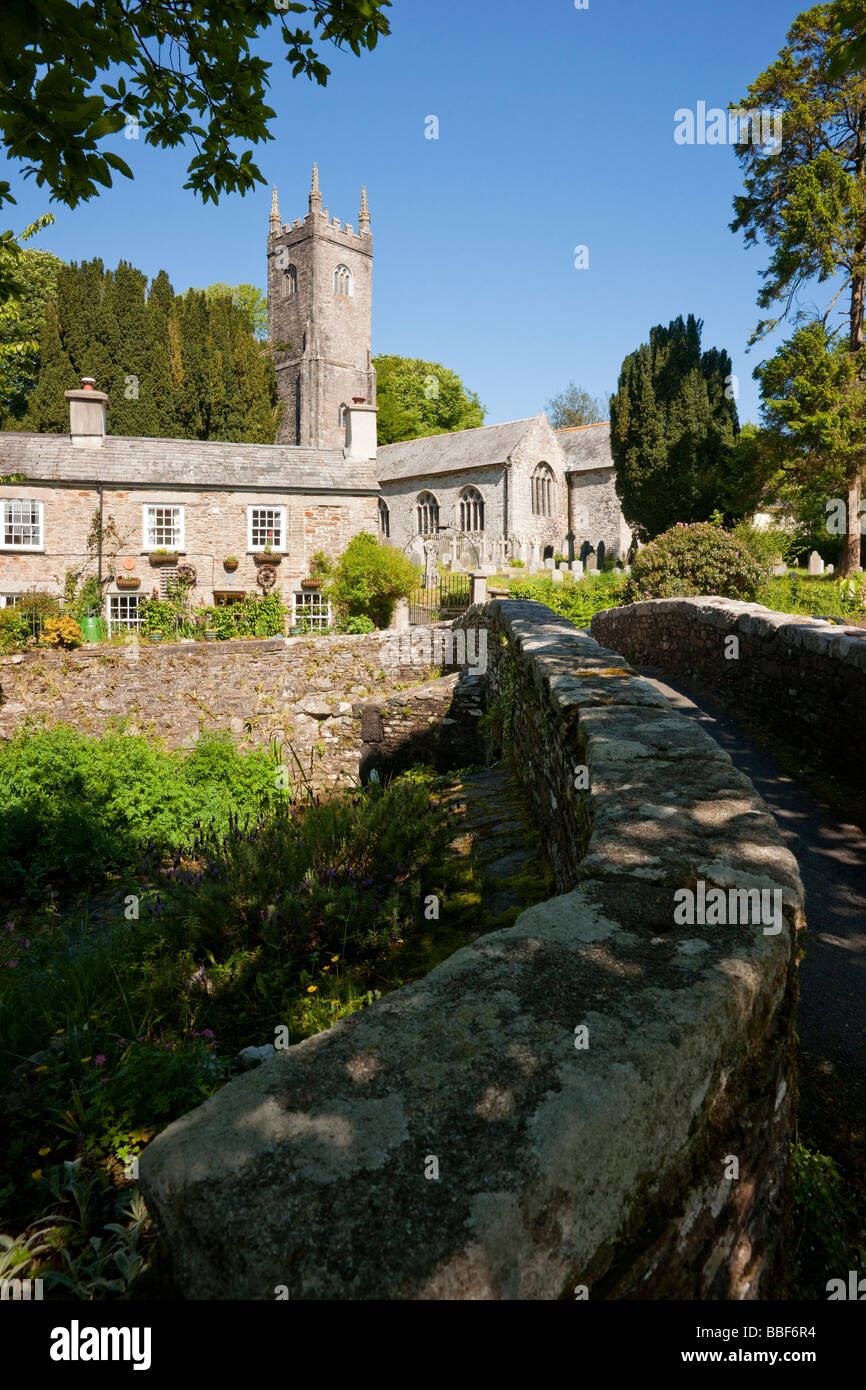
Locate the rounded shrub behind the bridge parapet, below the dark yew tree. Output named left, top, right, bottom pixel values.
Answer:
left=626, top=521, right=769, bottom=603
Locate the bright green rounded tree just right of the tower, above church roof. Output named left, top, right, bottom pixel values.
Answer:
left=373, top=354, right=485, bottom=445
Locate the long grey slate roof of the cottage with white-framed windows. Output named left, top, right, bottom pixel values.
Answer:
left=0, top=431, right=378, bottom=492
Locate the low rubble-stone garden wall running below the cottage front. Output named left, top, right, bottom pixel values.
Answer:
left=0, top=630, right=481, bottom=790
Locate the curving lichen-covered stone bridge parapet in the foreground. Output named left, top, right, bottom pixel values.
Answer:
left=140, top=600, right=803, bottom=1300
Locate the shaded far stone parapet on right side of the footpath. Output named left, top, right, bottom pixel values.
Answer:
left=592, top=598, right=866, bottom=781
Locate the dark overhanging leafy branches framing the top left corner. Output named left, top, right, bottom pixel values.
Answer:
left=0, top=0, right=391, bottom=207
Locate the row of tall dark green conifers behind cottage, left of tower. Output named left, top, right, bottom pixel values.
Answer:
left=21, top=260, right=282, bottom=443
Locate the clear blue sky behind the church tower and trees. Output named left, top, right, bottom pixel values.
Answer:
left=3, top=0, right=805, bottom=424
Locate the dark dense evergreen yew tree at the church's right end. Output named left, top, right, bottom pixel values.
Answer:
left=610, top=314, right=740, bottom=541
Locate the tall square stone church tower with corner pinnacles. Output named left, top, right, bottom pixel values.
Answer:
left=268, top=164, right=375, bottom=449
